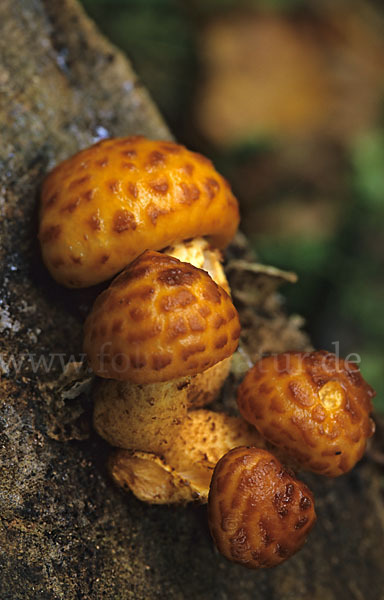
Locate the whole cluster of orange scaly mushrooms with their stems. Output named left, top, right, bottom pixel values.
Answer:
left=39, top=136, right=374, bottom=568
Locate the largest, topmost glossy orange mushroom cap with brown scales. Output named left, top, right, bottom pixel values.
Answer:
left=39, top=136, right=239, bottom=287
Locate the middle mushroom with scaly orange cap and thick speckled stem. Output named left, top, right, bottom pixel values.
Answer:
left=84, top=251, right=240, bottom=453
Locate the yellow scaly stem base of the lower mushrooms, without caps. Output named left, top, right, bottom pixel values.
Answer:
left=109, top=409, right=265, bottom=504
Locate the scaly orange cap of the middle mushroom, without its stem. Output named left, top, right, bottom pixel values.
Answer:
left=84, top=251, right=240, bottom=384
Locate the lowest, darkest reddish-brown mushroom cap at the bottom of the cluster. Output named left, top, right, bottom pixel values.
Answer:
left=208, top=446, right=316, bottom=569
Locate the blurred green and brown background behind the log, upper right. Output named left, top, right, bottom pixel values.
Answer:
left=79, top=0, right=384, bottom=412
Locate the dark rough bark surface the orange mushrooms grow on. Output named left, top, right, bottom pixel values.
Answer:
left=0, top=0, right=384, bottom=600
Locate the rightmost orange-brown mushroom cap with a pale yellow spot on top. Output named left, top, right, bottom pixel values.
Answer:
left=238, top=351, right=375, bottom=477
